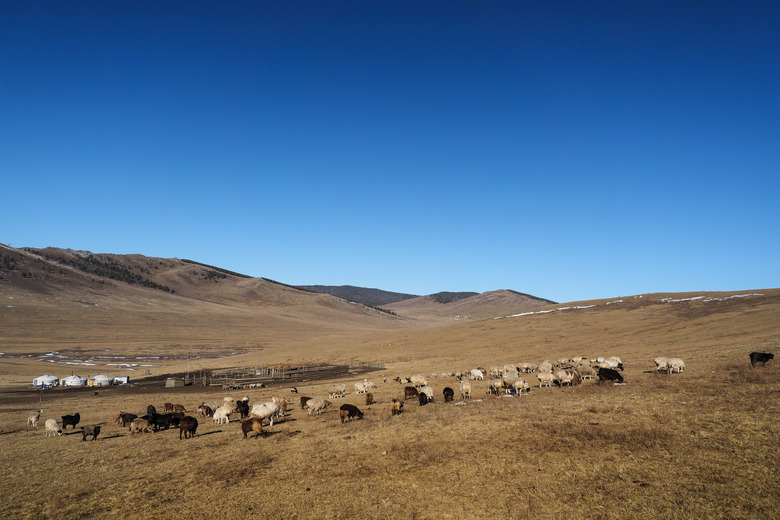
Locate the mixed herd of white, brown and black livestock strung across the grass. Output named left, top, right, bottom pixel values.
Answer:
left=22, top=356, right=700, bottom=441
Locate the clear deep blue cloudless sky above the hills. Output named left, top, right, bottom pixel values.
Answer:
left=0, top=1, right=780, bottom=301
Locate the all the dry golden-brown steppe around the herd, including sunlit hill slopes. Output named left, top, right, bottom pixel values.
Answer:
left=0, top=250, right=780, bottom=519
